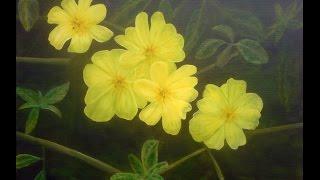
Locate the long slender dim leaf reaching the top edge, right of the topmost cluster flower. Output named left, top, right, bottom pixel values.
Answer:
left=184, top=0, right=205, bottom=53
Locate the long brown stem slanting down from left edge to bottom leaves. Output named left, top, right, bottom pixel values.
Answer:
left=16, top=132, right=121, bottom=174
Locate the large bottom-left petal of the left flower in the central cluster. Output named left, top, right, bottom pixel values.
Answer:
left=84, top=91, right=115, bottom=122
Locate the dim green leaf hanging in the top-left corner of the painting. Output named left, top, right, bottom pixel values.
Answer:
left=18, top=0, right=39, bottom=31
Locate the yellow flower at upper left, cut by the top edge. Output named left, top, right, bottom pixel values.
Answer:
left=48, top=0, right=113, bottom=53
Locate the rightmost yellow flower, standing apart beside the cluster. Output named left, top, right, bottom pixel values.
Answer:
left=189, top=78, right=263, bottom=150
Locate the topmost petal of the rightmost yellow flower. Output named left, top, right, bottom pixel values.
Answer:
left=221, top=78, right=247, bottom=104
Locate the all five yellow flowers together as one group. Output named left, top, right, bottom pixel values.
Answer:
left=48, top=0, right=263, bottom=149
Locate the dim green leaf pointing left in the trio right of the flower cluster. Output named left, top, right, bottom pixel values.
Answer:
left=195, top=39, right=225, bottom=59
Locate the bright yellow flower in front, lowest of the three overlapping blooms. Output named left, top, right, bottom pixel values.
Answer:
left=134, top=62, right=198, bottom=135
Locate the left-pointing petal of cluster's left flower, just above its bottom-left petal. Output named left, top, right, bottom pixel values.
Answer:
left=84, top=81, right=112, bottom=105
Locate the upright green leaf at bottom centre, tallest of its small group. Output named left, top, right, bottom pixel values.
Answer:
left=141, top=140, right=159, bottom=169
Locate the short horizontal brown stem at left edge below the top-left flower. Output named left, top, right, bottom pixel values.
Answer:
left=16, top=56, right=70, bottom=65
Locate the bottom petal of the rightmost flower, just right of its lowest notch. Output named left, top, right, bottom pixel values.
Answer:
left=224, top=122, right=246, bottom=149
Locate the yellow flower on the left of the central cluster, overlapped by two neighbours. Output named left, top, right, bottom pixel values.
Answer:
left=83, top=49, right=146, bottom=122
